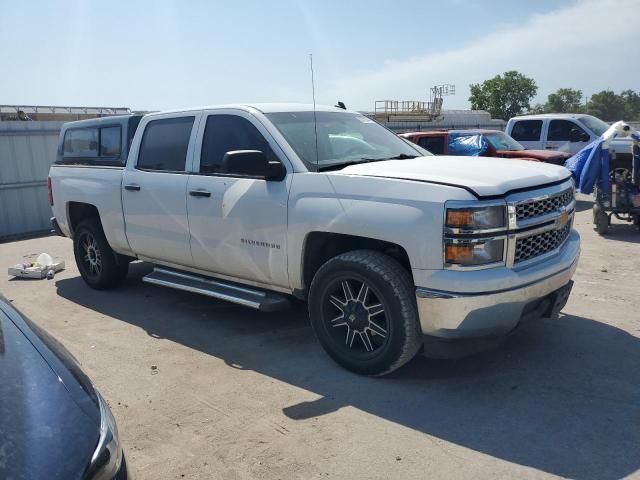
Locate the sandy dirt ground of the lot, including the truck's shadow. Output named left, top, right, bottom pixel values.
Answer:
left=0, top=196, right=640, bottom=480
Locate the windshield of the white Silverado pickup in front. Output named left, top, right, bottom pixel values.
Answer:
left=266, top=111, right=423, bottom=171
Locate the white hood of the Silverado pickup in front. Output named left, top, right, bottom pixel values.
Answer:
left=336, top=156, right=571, bottom=198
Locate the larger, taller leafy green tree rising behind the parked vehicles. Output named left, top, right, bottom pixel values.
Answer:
left=469, top=70, right=538, bottom=120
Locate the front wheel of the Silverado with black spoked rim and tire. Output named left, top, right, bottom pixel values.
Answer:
left=309, top=250, right=422, bottom=376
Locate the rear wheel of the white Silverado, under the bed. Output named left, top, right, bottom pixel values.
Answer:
left=73, top=219, right=129, bottom=290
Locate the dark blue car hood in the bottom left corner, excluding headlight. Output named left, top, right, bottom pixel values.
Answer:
left=0, top=299, right=100, bottom=480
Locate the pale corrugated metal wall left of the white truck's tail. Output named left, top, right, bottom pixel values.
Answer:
left=0, top=122, right=63, bottom=239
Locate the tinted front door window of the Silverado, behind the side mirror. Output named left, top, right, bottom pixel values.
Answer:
left=200, top=115, right=276, bottom=173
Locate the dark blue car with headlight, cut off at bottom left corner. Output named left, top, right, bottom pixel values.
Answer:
left=0, top=296, right=128, bottom=480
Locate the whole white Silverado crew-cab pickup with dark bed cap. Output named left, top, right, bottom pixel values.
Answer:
left=50, top=104, right=580, bottom=375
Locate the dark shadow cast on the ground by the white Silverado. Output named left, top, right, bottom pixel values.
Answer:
left=56, top=264, right=640, bottom=479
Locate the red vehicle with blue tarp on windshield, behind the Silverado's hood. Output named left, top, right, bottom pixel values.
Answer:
left=400, top=130, right=570, bottom=165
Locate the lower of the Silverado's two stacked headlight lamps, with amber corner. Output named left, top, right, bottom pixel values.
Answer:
left=445, top=238, right=505, bottom=267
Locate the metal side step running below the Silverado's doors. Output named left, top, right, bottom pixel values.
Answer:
left=142, top=267, right=290, bottom=312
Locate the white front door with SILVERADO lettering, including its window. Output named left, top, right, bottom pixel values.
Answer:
left=187, top=110, right=291, bottom=287
